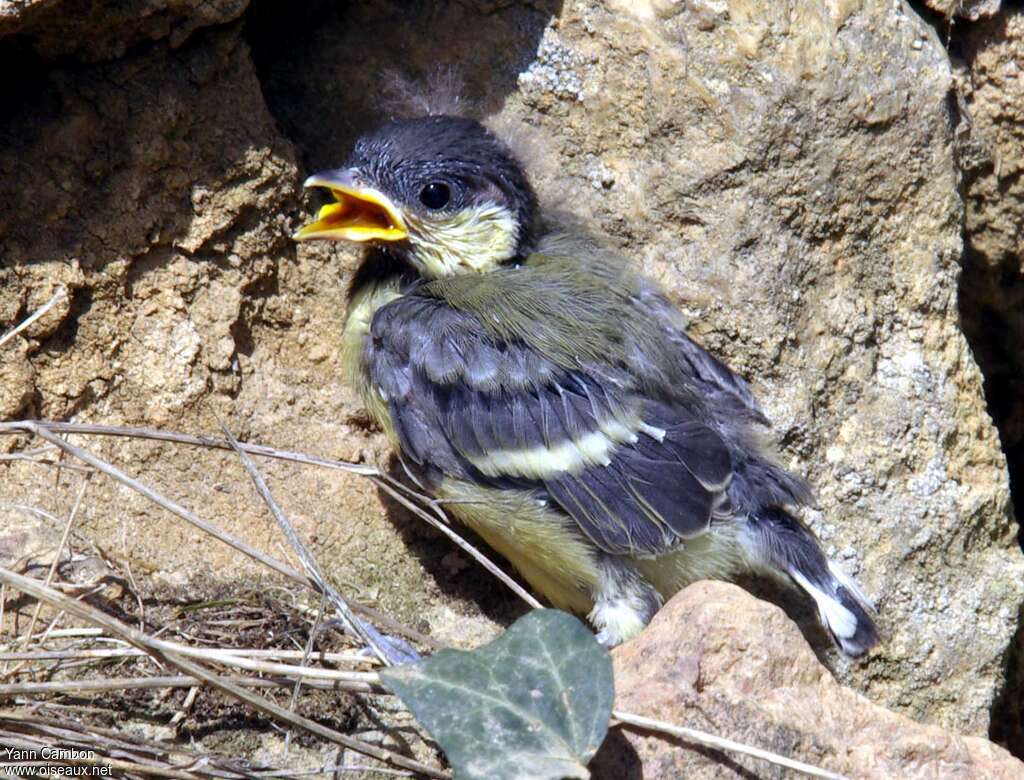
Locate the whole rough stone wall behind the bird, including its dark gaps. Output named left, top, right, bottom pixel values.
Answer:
left=0, top=0, right=1024, bottom=769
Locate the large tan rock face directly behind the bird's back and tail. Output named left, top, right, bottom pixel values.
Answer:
left=485, top=2, right=1024, bottom=734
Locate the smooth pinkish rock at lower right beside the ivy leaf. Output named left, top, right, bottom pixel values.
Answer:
left=591, top=582, right=1024, bottom=780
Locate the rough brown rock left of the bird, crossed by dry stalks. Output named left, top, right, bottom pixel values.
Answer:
left=0, top=16, right=515, bottom=643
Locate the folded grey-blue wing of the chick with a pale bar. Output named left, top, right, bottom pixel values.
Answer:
left=366, top=295, right=732, bottom=556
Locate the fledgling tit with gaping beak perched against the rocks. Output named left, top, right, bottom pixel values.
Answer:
left=293, top=115, right=879, bottom=657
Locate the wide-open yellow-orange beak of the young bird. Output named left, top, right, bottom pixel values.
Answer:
left=292, top=170, right=409, bottom=242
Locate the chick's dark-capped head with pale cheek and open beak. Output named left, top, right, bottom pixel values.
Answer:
left=293, top=117, right=538, bottom=278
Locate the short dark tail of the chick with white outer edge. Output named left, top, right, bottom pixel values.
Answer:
left=749, top=508, right=879, bottom=657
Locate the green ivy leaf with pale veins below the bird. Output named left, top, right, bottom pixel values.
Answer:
left=381, top=609, right=614, bottom=780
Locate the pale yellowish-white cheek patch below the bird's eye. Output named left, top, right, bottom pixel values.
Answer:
left=407, top=204, right=519, bottom=278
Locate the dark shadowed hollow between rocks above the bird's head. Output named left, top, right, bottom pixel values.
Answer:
left=245, top=0, right=562, bottom=171
